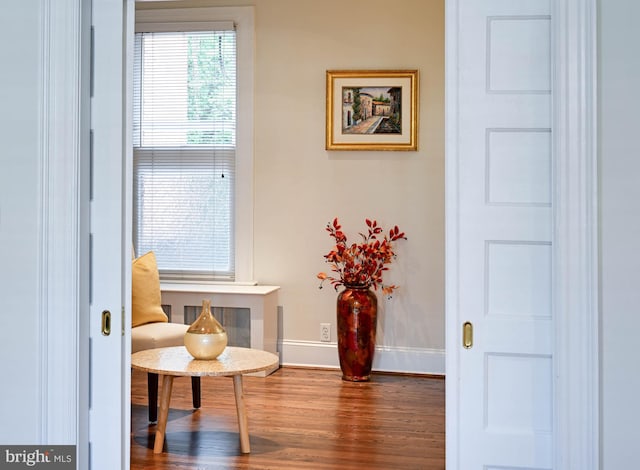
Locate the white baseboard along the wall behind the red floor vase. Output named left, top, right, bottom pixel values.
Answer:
left=278, top=340, right=445, bottom=375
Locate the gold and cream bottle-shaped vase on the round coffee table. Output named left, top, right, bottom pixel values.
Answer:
left=184, top=300, right=227, bottom=360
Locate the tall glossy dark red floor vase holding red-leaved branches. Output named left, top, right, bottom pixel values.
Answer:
left=337, top=285, right=378, bottom=382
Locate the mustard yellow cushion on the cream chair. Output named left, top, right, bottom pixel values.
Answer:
left=131, top=251, right=169, bottom=327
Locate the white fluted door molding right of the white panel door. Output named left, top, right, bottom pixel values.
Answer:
left=553, top=0, right=600, bottom=470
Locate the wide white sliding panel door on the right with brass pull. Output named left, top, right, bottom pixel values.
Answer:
left=447, top=0, right=554, bottom=470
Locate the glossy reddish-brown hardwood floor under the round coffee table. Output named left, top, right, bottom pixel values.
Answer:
left=131, top=368, right=445, bottom=470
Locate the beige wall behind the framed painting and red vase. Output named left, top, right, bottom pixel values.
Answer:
left=139, top=0, right=444, bottom=368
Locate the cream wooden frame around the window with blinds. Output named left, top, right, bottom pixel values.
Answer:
left=135, top=5, right=256, bottom=284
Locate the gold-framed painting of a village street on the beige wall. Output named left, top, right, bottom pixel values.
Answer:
left=326, top=70, right=418, bottom=150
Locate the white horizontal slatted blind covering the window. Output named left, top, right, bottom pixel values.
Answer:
left=133, top=30, right=237, bottom=280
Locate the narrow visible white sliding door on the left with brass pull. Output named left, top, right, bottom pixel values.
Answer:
left=89, top=0, right=132, bottom=470
